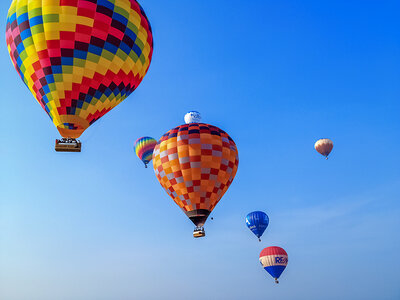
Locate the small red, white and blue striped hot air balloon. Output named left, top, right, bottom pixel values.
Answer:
left=260, top=246, right=288, bottom=283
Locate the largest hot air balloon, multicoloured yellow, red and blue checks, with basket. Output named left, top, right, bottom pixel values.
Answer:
left=6, top=0, right=153, bottom=151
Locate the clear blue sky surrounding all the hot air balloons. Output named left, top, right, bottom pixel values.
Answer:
left=0, top=0, right=400, bottom=300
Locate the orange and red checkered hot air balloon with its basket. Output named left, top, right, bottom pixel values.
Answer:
left=153, top=123, right=239, bottom=237
